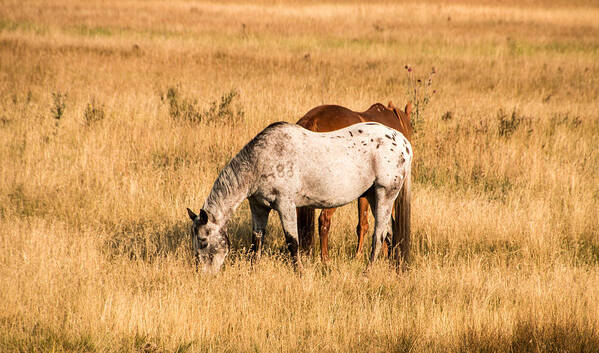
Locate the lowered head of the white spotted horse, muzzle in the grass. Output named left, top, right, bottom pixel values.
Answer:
left=187, top=208, right=229, bottom=273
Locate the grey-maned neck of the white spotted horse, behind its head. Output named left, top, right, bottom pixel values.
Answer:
left=203, top=156, right=255, bottom=226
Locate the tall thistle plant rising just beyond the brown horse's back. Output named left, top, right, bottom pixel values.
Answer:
left=404, top=65, right=437, bottom=133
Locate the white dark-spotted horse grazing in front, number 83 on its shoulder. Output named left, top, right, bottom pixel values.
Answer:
left=187, top=122, right=412, bottom=272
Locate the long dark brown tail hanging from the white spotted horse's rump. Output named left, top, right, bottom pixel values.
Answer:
left=392, top=170, right=412, bottom=270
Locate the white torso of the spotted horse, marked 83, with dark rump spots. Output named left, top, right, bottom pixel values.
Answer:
left=248, top=122, right=411, bottom=208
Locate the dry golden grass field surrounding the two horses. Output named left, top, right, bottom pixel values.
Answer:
left=0, top=0, right=599, bottom=353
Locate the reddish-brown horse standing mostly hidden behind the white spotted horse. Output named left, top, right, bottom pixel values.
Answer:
left=297, top=102, right=412, bottom=264
